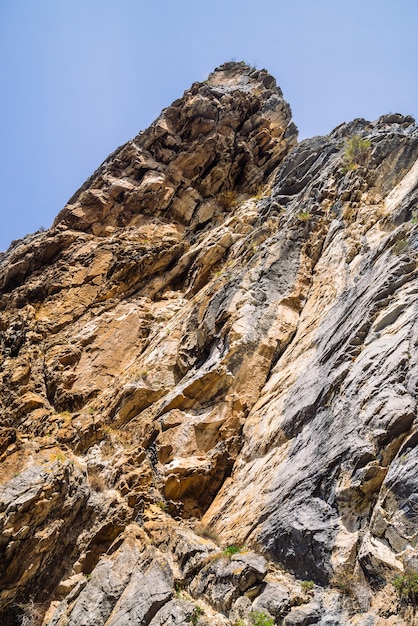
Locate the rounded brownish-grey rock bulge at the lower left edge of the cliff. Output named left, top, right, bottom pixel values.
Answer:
left=0, top=455, right=89, bottom=611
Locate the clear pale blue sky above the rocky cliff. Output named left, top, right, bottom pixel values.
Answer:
left=0, top=0, right=418, bottom=250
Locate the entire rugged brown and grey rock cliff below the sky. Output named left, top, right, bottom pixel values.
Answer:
left=0, top=63, right=418, bottom=626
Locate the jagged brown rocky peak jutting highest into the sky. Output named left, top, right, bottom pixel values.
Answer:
left=50, top=62, right=297, bottom=239
